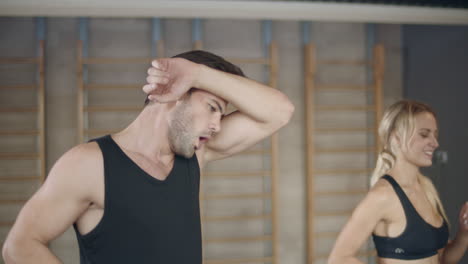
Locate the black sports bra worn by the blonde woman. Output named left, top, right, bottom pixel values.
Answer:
left=372, top=175, right=449, bottom=260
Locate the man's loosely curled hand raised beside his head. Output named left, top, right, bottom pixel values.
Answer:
left=143, top=58, right=199, bottom=103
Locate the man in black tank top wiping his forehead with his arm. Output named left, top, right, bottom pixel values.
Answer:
left=3, top=51, right=294, bottom=264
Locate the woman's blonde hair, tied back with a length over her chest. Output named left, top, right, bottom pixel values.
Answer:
left=370, top=100, right=448, bottom=222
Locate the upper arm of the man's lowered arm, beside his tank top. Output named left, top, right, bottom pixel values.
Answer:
left=10, top=145, right=98, bottom=243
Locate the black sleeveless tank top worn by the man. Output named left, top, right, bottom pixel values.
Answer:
left=74, top=136, right=202, bottom=264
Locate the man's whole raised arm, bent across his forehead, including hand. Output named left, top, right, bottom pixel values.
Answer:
left=143, top=58, right=294, bottom=162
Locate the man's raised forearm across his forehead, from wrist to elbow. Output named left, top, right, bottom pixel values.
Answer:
left=195, top=65, right=294, bottom=126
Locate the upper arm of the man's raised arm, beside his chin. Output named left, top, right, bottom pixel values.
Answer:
left=204, top=111, right=275, bottom=161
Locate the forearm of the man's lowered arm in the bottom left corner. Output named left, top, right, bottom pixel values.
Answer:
left=2, top=240, right=62, bottom=264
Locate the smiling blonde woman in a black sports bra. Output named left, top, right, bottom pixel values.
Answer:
left=328, top=100, right=468, bottom=264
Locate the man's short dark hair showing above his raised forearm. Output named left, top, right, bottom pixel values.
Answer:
left=145, top=50, right=245, bottom=105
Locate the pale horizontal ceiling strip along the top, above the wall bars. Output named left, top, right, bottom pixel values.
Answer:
left=0, top=0, right=468, bottom=25
